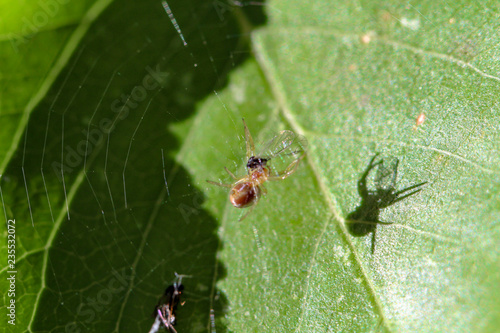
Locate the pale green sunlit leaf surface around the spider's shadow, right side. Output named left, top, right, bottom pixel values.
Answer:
left=186, top=1, right=500, bottom=332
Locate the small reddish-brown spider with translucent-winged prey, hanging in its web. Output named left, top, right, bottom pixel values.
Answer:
left=207, top=119, right=307, bottom=221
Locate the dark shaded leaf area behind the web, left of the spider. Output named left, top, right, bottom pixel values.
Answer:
left=0, top=0, right=265, bottom=332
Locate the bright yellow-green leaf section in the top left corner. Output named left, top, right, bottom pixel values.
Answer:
left=0, top=0, right=114, bottom=175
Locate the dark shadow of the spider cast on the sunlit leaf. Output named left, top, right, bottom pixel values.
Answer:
left=346, top=154, right=427, bottom=254
